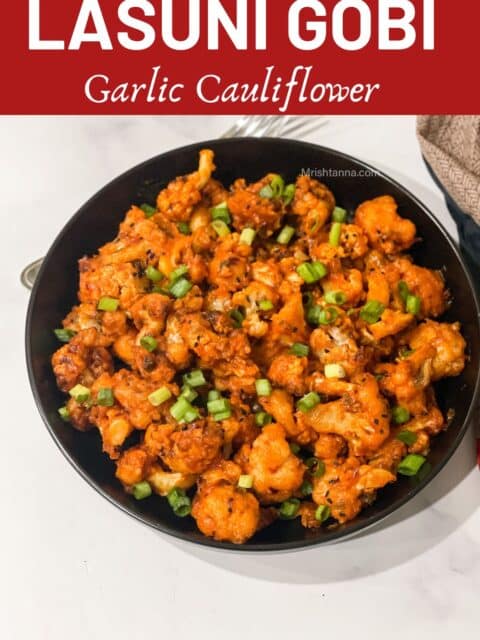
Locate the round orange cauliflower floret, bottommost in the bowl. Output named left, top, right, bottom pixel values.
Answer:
left=192, top=461, right=260, bottom=544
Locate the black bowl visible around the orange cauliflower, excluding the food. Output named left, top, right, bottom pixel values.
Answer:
left=26, top=138, right=480, bottom=551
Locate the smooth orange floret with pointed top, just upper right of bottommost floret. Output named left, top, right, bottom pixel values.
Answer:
left=238, top=423, right=306, bottom=504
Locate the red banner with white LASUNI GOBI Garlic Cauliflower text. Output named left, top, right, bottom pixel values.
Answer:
left=0, top=0, right=480, bottom=115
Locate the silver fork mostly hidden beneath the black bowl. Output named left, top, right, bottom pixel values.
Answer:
left=20, top=116, right=328, bottom=289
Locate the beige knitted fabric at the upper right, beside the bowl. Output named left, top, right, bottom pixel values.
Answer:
left=417, top=116, right=480, bottom=224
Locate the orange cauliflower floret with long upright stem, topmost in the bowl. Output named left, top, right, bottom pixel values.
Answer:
left=157, top=149, right=215, bottom=222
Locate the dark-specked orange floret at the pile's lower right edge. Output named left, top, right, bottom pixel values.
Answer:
left=312, top=458, right=395, bottom=523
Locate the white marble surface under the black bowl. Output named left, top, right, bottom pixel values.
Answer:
left=0, top=117, right=480, bottom=640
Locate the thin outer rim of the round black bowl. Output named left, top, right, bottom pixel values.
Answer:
left=25, top=137, right=480, bottom=553
